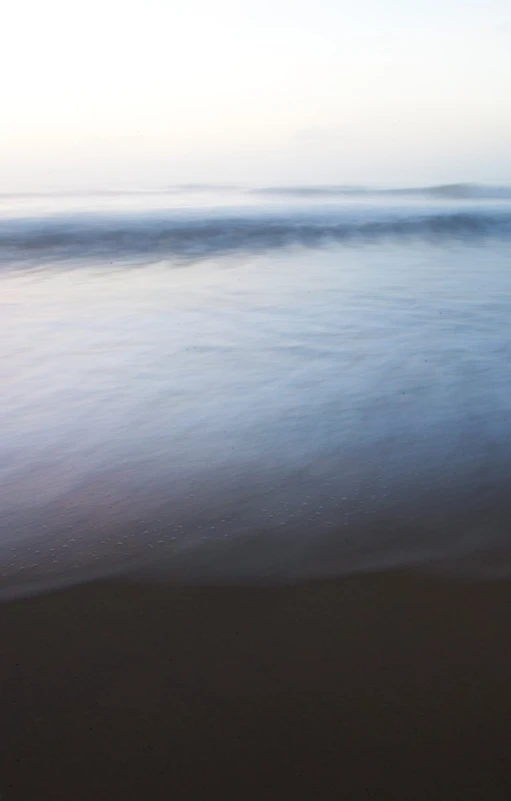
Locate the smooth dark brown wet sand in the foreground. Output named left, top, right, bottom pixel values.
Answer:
left=0, top=574, right=511, bottom=801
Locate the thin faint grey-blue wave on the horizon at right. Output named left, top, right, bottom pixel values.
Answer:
left=252, top=183, right=511, bottom=200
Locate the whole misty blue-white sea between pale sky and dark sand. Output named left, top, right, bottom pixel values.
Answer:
left=0, top=185, right=511, bottom=594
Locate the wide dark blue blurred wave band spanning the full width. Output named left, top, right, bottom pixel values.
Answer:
left=0, top=209, right=511, bottom=264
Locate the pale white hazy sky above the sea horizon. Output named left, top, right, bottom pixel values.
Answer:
left=0, top=0, right=511, bottom=191
